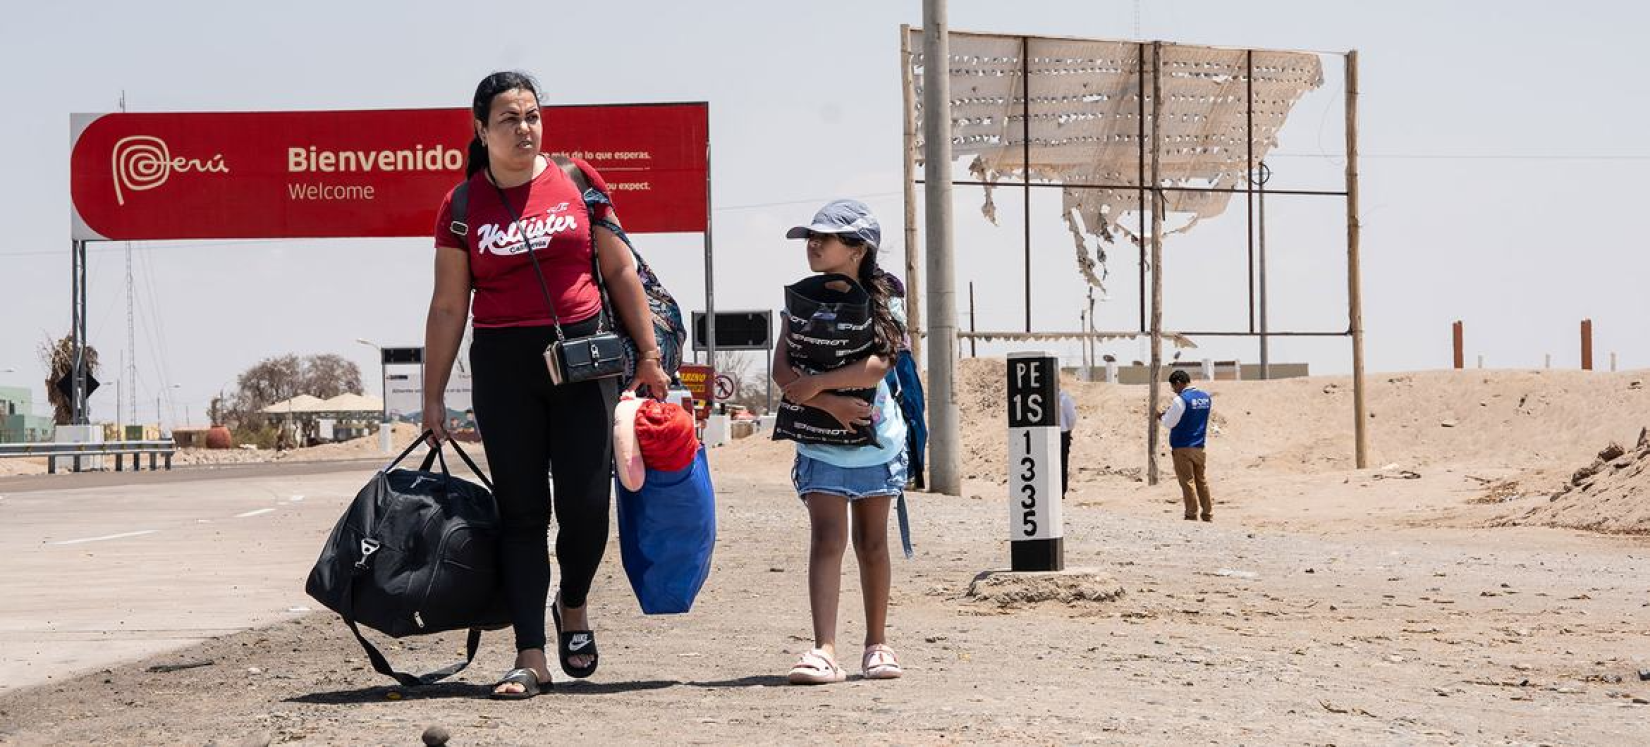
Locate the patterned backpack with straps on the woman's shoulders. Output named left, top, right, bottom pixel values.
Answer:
left=449, top=155, right=688, bottom=380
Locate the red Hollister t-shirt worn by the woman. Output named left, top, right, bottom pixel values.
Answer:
left=436, top=158, right=612, bottom=328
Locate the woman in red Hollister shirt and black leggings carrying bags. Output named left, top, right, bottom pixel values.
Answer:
left=424, top=73, right=670, bottom=699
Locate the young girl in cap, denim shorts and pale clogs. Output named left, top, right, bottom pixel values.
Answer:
left=774, top=200, right=908, bottom=684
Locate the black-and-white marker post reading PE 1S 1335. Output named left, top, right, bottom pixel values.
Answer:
left=1008, top=351, right=1066, bottom=572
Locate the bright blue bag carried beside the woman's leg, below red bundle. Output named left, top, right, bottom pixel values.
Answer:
left=614, top=447, right=716, bottom=615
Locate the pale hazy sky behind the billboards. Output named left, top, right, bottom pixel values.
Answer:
left=0, top=0, right=1650, bottom=425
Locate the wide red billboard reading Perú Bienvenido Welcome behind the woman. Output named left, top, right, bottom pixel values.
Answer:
left=69, top=104, right=710, bottom=241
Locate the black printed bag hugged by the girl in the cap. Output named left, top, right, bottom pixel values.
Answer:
left=774, top=274, right=876, bottom=447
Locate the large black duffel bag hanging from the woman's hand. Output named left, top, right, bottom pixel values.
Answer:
left=304, top=430, right=510, bottom=686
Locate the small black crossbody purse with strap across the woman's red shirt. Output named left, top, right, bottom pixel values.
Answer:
left=487, top=158, right=624, bottom=386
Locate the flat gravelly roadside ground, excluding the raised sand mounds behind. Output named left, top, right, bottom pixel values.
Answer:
left=0, top=435, right=1650, bottom=745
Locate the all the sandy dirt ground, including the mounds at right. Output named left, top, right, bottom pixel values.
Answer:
left=0, top=361, right=1650, bottom=745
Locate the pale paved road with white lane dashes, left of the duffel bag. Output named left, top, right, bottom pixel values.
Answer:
left=0, top=460, right=399, bottom=691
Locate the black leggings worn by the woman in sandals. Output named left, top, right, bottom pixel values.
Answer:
left=470, top=318, right=619, bottom=650
